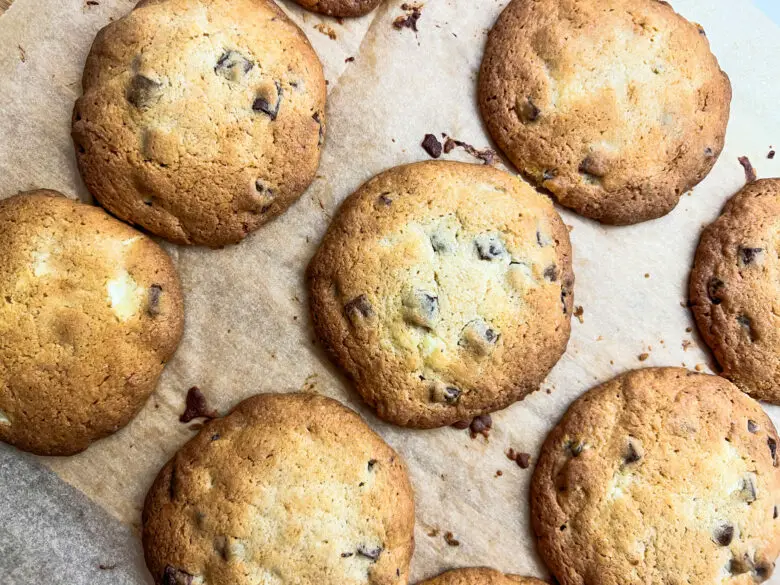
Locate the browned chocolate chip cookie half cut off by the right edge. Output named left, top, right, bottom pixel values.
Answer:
left=690, top=179, right=780, bottom=404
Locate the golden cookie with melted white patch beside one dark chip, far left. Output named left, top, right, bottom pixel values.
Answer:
left=0, top=190, right=184, bottom=455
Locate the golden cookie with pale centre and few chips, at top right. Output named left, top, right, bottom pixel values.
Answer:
left=479, top=0, right=731, bottom=224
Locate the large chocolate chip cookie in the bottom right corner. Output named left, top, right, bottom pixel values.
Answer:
left=531, top=368, right=780, bottom=585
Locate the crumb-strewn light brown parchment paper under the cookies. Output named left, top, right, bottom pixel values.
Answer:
left=0, top=0, right=780, bottom=583
